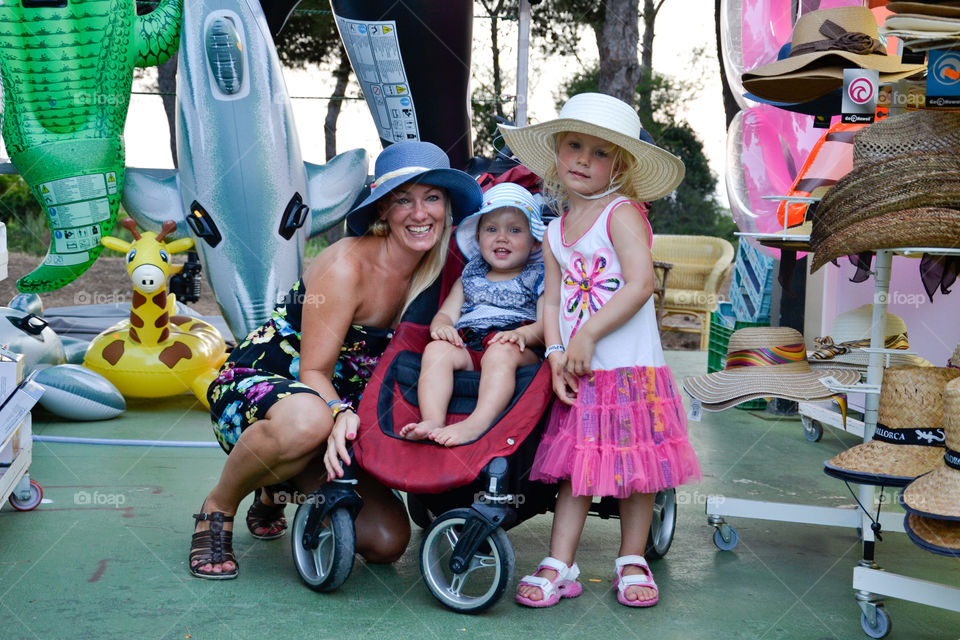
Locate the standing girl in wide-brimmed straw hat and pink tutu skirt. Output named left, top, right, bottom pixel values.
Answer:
left=501, top=93, right=700, bottom=607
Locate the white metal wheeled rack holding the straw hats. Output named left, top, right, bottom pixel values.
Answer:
left=706, top=3, right=960, bottom=638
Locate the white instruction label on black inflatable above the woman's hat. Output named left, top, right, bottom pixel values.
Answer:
left=336, top=16, right=420, bottom=142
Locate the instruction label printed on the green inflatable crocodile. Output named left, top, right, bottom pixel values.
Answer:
left=37, top=171, right=117, bottom=266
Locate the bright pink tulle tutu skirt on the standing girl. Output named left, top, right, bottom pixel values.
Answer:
left=530, top=366, right=700, bottom=498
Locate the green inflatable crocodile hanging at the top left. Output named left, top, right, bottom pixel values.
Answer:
left=0, top=0, right=183, bottom=292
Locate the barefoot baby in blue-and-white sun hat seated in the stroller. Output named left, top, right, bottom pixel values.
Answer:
left=400, top=182, right=543, bottom=447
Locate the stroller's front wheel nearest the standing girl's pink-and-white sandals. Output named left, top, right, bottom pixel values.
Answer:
left=420, top=509, right=516, bottom=613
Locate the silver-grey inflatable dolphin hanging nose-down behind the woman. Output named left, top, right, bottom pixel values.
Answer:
left=123, top=0, right=368, bottom=339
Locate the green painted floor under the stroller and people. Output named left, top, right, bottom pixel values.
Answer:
left=0, top=352, right=960, bottom=640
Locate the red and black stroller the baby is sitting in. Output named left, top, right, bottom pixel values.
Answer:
left=291, top=236, right=677, bottom=613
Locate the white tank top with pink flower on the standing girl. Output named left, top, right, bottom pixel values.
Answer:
left=547, top=197, right=666, bottom=370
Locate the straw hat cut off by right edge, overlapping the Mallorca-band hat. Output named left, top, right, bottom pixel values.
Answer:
left=903, top=376, right=960, bottom=520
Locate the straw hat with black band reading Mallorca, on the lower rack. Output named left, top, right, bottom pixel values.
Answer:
left=823, top=367, right=960, bottom=486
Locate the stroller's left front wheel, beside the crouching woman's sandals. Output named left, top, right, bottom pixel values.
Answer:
left=290, top=501, right=357, bottom=592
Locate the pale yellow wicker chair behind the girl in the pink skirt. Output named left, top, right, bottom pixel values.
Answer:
left=653, top=234, right=733, bottom=349
